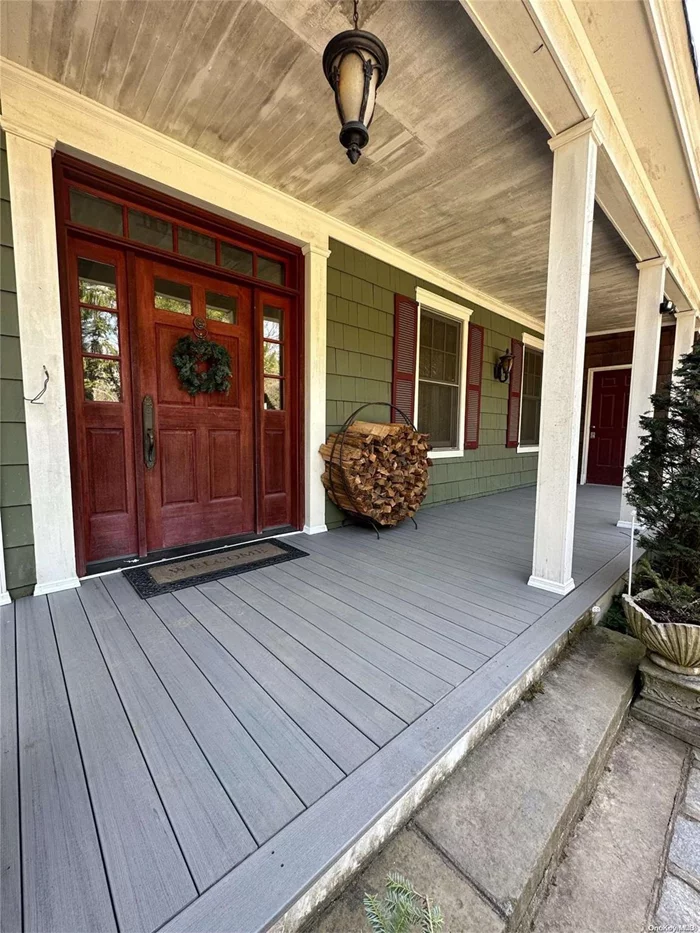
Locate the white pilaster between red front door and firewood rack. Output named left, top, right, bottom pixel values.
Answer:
left=302, top=238, right=331, bottom=535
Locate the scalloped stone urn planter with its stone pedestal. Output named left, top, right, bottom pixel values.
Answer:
left=622, top=590, right=700, bottom=748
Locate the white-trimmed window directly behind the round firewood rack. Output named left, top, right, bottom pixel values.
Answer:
left=415, top=288, right=472, bottom=457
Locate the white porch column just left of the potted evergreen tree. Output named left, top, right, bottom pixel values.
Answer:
left=617, top=256, right=666, bottom=528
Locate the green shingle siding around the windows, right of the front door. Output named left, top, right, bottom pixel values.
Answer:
left=326, top=240, right=537, bottom=526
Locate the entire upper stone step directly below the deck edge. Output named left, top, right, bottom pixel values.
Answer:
left=313, top=628, right=643, bottom=933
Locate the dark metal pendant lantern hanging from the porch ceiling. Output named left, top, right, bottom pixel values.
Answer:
left=323, top=0, right=389, bottom=165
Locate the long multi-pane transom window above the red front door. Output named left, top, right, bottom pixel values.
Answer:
left=68, top=185, right=292, bottom=284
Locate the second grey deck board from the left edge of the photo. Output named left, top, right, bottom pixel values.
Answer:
left=16, top=596, right=117, bottom=933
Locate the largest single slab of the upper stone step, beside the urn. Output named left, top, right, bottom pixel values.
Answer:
left=415, top=628, right=643, bottom=930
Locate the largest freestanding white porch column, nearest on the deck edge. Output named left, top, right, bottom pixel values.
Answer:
left=528, top=118, right=600, bottom=595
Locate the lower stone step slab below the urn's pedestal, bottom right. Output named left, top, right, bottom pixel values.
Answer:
left=532, top=719, right=684, bottom=933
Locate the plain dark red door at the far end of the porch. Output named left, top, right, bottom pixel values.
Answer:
left=586, top=369, right=631, bottom=486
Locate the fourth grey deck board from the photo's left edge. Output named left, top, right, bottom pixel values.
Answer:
left=79, top=580, right=256, bottom=892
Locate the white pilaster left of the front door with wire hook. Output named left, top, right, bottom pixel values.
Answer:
left=3, top=127, right=80, bottom=595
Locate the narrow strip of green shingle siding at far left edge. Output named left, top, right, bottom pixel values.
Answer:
left=0, top=135, right=36, bottom=598
